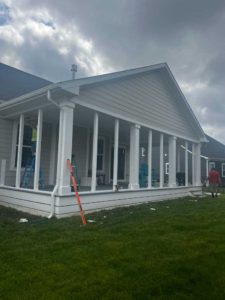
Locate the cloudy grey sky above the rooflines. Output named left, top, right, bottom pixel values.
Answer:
left=0, top=0, right=225, bottom=143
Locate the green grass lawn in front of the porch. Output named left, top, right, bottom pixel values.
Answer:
left=0, top=196, right=225, bottom=300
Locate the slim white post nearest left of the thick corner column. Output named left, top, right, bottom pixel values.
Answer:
left=34, top=109, right=43, bottom=190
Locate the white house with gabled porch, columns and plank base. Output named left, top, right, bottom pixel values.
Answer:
left=0, top=63, right=206, bottom=217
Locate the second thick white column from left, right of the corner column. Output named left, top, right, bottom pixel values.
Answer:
left=129, top=124, right=141, bottom=190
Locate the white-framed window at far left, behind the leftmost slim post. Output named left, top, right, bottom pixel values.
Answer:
left=11, top=123, right=32, bottom=169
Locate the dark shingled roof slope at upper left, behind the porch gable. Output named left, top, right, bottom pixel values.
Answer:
left=0, top=63, right=51, bottom=103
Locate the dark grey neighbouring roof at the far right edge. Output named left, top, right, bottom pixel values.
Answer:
left=201, top=135, right=225, bottom=161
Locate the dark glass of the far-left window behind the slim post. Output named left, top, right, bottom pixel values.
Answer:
left=15, top=125, right=32, bottom=168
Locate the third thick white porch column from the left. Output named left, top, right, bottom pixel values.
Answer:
left=169, top=136, right=177, bottom=187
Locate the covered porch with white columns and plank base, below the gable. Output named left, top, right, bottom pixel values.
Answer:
left=0, top=85, right=201, bottom=217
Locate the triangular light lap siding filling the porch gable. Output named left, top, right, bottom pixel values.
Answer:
left=76, top=72, right=197, bottom=139
